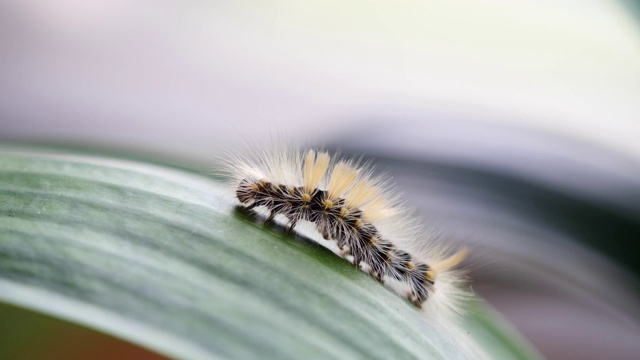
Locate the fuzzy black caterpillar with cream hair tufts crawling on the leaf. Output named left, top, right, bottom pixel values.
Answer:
left=228, top=146, right=466, bottom=313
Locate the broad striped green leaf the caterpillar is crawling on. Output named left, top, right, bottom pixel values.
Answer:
left=0, top=146, right=536, bottom=359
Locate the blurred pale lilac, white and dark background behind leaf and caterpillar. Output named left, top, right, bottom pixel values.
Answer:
left=0, top=0, right=640, bottom=359
